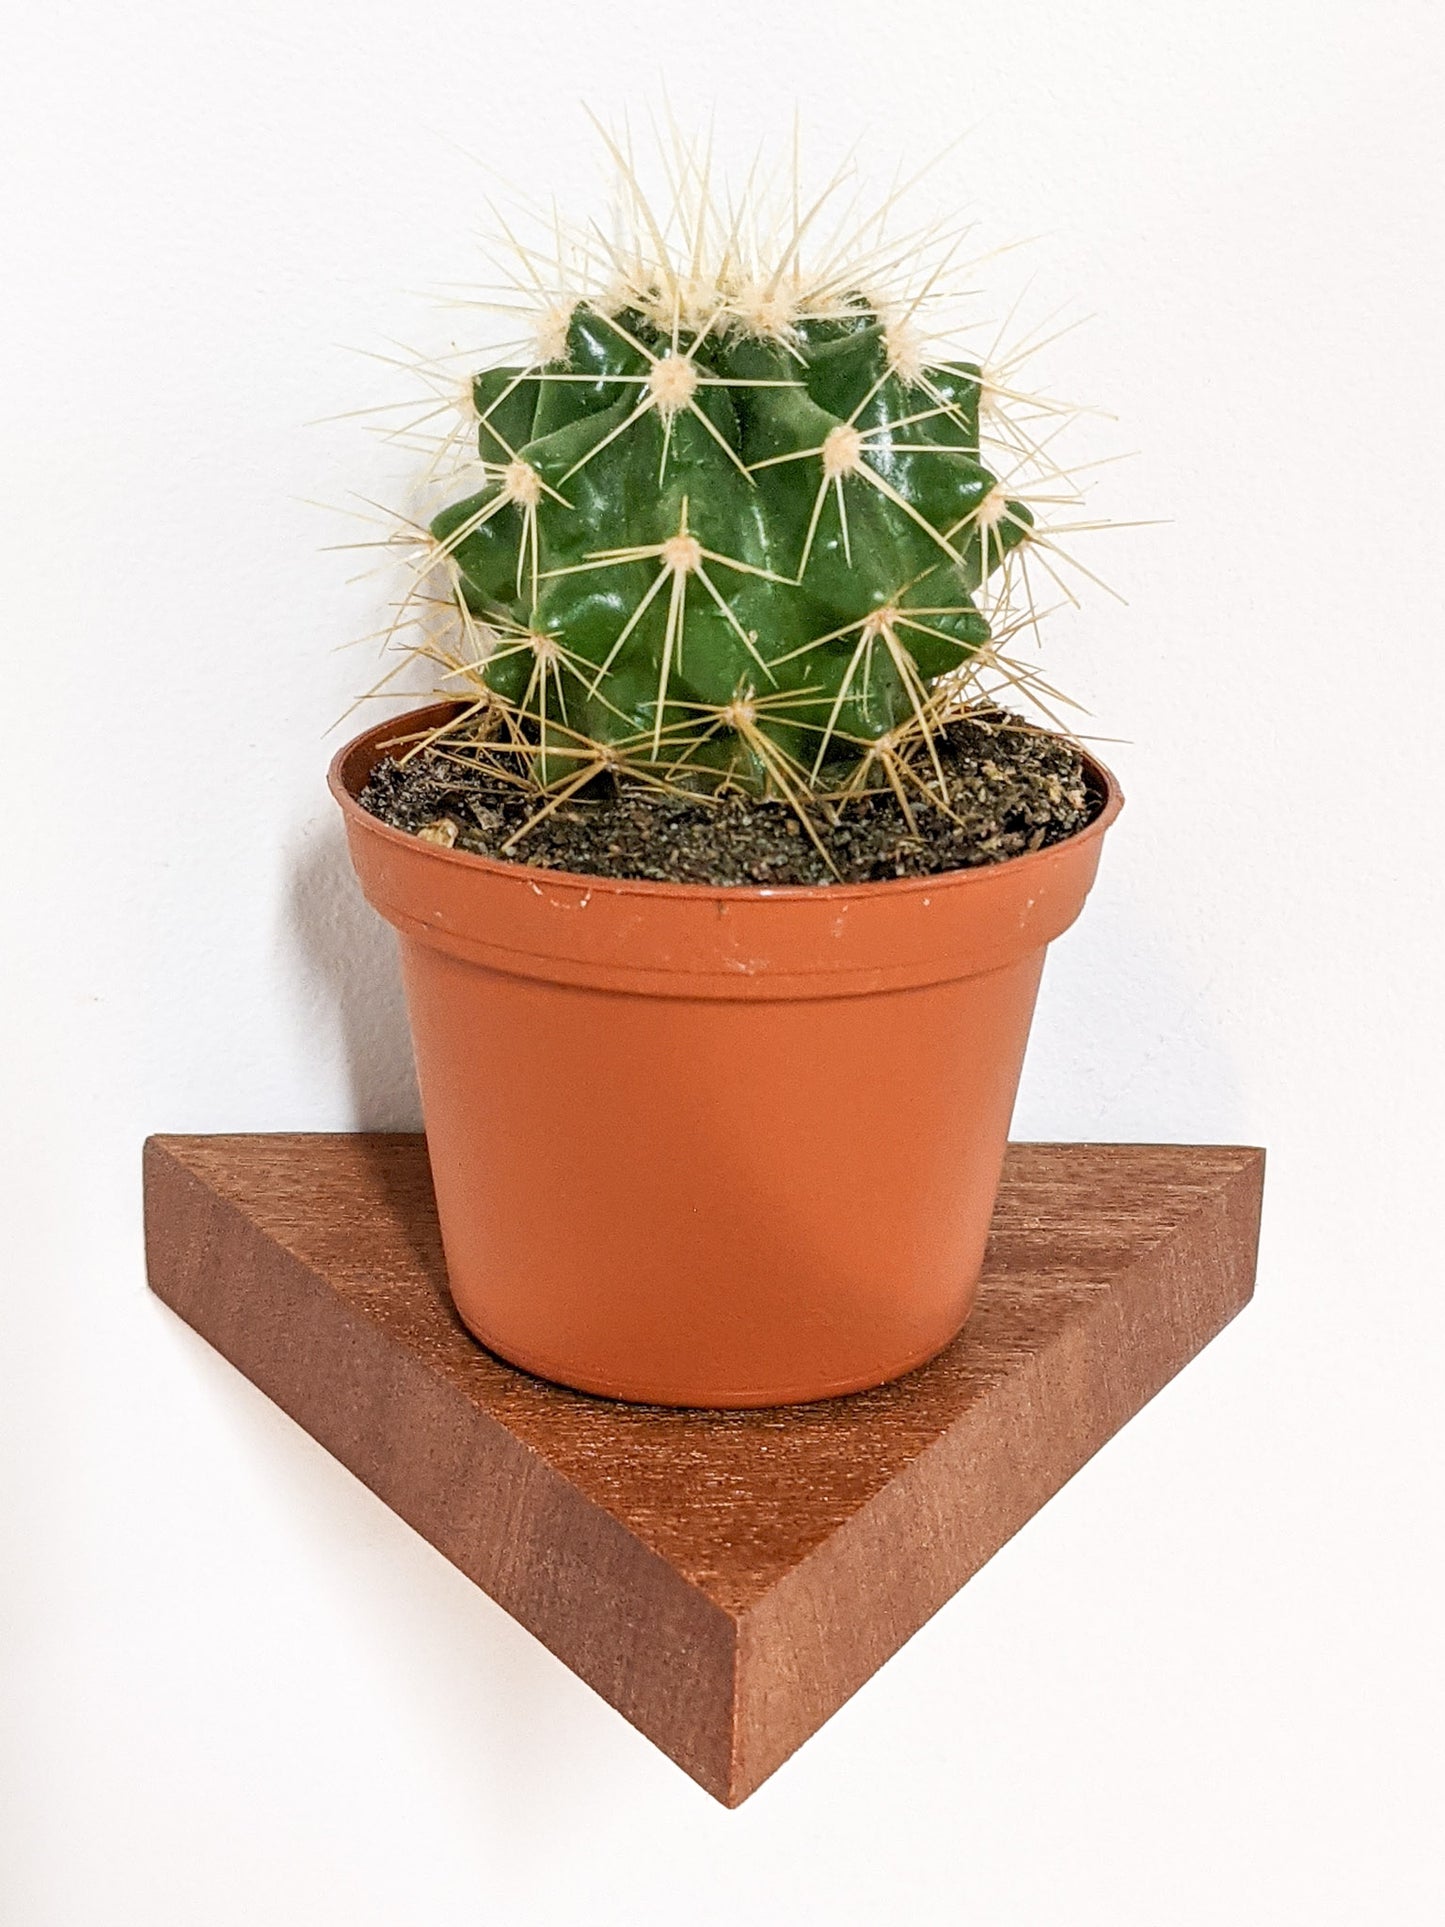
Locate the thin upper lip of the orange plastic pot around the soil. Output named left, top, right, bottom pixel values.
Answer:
left=326, top=701, right=1123, bottom=904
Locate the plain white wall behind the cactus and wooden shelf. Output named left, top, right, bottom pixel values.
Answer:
left=0, top=0, right=1445, bottom=1927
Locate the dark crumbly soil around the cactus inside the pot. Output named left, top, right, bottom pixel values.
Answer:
left=360, top=709, right=1102, bottom=886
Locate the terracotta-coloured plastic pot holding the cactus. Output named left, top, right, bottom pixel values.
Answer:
left=331, top=707, right=1121, bottom=1407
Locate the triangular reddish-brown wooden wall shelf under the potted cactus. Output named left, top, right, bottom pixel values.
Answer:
left=146, top=1135, right=1264, bottom=1806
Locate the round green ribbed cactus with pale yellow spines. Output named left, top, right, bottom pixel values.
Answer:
left=432, top=295, right=1033, bottom=800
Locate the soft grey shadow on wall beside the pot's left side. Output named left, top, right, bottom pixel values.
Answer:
left=287, top=821, right=422, bottom=1131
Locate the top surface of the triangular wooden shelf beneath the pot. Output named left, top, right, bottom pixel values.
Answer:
left=147, top=1133, right=1262, bottom=1615
